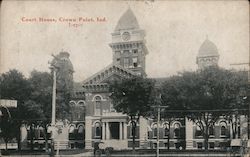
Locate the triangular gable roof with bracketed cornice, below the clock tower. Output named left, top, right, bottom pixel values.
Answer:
left=83, top=64, right=136, bottom=86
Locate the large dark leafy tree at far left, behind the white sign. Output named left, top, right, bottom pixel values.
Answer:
left=0, top=70, right=48, bottom=149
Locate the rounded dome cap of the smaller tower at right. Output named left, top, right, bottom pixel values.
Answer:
left=197, top=39, right=219, bottom=57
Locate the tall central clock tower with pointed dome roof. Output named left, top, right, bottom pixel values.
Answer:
left=109, top=8, right=148, bottom=77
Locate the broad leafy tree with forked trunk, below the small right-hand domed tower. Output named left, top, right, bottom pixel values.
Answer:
left=162, top=67, right=246, bottom=150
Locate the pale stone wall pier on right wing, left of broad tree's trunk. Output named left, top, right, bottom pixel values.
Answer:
left=185, top=117, right=193, bottom=149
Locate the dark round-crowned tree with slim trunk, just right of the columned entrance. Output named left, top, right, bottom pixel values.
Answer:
left=110, top=77, right=155, bottom=151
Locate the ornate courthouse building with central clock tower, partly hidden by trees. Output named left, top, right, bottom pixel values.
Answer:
left=20, top=8, right=248, bottom=149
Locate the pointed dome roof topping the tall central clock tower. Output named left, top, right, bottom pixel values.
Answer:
left=115, top=8, right=139, bottom=31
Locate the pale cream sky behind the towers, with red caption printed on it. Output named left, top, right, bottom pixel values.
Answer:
left=0, top=0, right=249, bottom=82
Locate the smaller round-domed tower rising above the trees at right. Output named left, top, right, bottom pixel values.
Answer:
left=196, top=38, right=219, bottom=69
